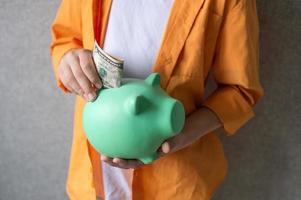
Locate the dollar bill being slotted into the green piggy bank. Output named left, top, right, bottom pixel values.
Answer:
left=93, top=41, right=124, bottom=88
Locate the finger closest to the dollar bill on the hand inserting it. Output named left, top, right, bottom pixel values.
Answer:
left=79, top=51, right=102, bottom=89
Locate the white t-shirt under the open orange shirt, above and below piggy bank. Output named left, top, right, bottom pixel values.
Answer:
left=102, top=0, right=173, bottom=200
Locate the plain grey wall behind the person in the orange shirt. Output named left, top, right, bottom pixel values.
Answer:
left=0, top=0, right=301, bottom=200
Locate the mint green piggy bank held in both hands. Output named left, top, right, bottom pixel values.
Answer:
left=83, top=73, right=185, bottom=164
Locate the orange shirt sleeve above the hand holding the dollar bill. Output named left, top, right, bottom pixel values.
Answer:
left=50, top=0, right=83, bottom=92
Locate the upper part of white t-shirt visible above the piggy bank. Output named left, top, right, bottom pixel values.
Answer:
left=103, top=0, right=172, bottom=78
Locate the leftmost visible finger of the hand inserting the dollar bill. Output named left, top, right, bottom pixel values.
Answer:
left=60, top=64, right=84, bottom=95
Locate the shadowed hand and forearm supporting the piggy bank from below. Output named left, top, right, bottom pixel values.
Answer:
left=101, top=107, right=222, bottom=169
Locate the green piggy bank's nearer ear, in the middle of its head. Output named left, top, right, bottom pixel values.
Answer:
left=125, top=95, right=150, bottom=115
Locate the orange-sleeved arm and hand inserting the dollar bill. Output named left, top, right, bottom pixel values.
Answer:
left=50, top=0, right=102, bottom=101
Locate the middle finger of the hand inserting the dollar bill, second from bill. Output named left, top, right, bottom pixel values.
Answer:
left=70, top=57, right=96, bottom=101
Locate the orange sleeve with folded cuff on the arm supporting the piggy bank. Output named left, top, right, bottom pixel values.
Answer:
left=203, top=0, right=263, bottom=135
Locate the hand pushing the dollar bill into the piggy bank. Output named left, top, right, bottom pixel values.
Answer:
left=58, top=49, right=102, bottom=101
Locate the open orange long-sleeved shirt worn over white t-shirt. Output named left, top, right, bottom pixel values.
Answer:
left=51, top=0, right=263, bottom=200
